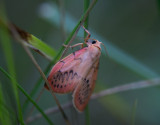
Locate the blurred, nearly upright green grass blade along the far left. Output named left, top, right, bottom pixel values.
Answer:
left=0, top=3, right=24, bottom=125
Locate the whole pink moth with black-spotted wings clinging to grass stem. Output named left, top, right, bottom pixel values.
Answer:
left=45, top=27, right=102, bottom=112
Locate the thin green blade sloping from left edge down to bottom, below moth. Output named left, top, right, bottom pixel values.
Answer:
left=0, top=67, right=53, bottom=125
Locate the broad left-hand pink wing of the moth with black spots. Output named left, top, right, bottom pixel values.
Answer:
left=45, top=48, right=87, bottom=94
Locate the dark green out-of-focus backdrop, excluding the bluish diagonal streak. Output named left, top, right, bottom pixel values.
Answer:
left=0, top=0, right=160, bottom=125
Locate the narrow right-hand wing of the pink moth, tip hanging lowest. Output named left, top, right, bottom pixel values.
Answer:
left=73, top=59, right=99, bottom=112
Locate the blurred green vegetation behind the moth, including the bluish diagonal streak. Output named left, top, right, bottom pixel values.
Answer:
left=0, top=0, right=160, bottom=125
